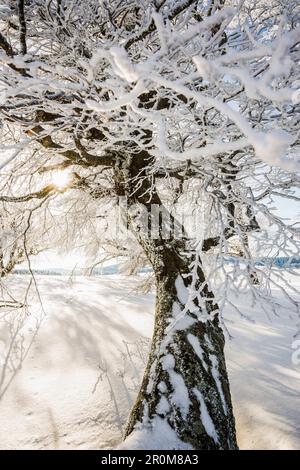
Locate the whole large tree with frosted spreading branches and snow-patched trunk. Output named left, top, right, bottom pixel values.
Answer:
left=0, top=0, right=300, bottom=449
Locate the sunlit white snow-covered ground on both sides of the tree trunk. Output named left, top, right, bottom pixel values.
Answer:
left=0, top=275, right=300, bottom=449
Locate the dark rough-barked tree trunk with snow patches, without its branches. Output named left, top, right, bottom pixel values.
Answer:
left=115, top=154, right=237, bottom=449
